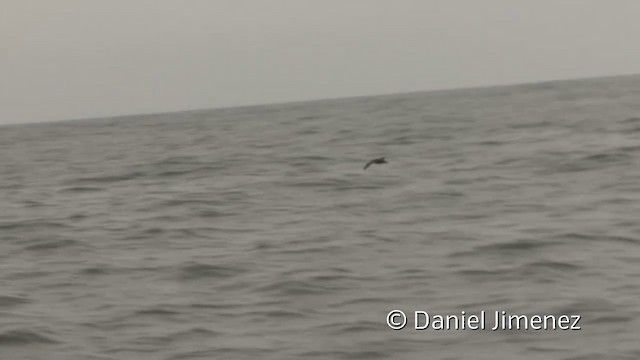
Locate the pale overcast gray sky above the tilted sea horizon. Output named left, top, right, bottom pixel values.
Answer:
left=0, top=0, right=640, bottom=123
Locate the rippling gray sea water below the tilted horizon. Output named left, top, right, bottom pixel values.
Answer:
left=0, top=76, right=640, bottom=360
